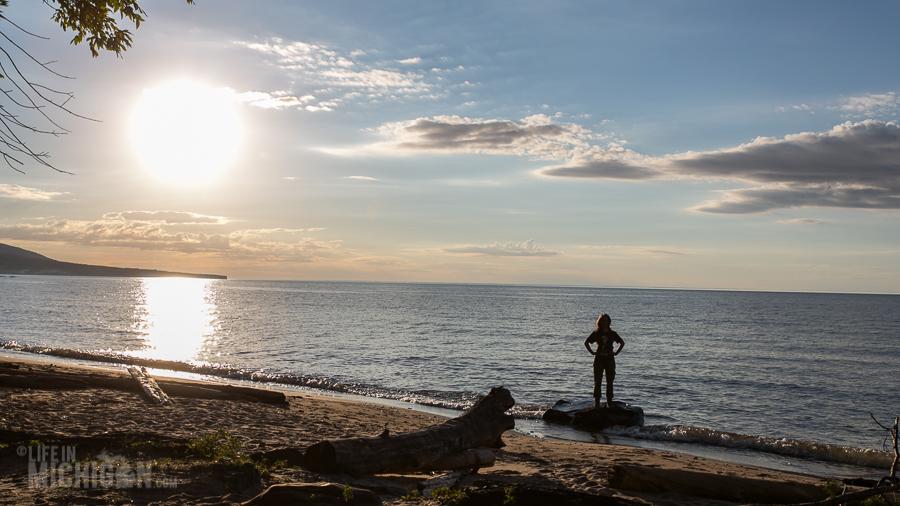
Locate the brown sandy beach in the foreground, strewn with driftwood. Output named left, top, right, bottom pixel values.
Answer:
left=0, top=358, right=868, bottom=505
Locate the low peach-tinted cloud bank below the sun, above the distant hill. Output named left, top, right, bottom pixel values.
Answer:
left=0, top=211, right=341, bottom=262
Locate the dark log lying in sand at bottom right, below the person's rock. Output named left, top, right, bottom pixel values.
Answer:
left=607, top=465, right=826, bottom=504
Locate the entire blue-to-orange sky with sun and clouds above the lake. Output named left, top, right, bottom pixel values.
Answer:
left=0, top=0, right=900, bottom=293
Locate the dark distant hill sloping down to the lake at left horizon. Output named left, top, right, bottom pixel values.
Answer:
left=0, top=244, right=228, bottom=279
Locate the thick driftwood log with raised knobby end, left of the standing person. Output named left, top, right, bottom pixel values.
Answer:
left=304, top=387, right=516, bottom=475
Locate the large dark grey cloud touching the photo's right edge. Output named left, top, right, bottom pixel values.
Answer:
left=539, top=120, right=900, bottom=214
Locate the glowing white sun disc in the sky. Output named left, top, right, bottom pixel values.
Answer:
left=131, top=81, right=241, bottom=183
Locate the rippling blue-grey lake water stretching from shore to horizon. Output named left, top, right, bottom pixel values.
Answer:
left=0, top=276, right=900, bottom=474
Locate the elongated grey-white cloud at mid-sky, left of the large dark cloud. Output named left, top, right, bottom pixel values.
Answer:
left=378, top=114, right=600, bottom=159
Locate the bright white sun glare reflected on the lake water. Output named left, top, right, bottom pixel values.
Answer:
left=133, top=278, right=217, bottom=362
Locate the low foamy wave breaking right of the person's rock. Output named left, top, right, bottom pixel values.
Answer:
left=603, top=425, right=894, bottom=469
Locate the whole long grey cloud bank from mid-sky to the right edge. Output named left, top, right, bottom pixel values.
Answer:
left=375, top=114, right=900, bottom=214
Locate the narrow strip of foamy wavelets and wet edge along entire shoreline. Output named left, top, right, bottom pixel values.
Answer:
left=0, top=342, right=893, bottom=477
